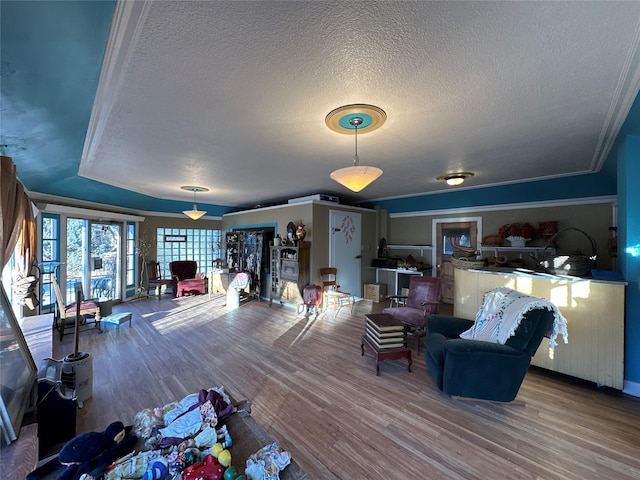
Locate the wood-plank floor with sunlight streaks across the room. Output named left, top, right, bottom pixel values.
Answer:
left=54, top=295, right=640, bottom=479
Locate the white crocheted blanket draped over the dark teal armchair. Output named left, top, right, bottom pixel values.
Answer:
left=460, top=287, right=569, bottom=358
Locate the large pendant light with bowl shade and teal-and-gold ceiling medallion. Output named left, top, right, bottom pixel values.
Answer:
left=324, top=104, right=387, bottom=192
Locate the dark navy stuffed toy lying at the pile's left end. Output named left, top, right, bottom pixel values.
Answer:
left=57, top=422, right=138, bottom=480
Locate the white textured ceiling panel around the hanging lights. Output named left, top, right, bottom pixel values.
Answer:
left=3, top=1, right=640, bottom=212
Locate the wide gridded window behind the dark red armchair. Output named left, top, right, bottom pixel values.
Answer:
left=156, top=228, right=223, bottom=278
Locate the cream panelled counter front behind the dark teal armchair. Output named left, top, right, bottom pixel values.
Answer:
left=454, top=267, right=627, bottom=390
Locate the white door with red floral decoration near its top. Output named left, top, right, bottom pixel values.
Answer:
left=328, top=210, right=362, bottom=297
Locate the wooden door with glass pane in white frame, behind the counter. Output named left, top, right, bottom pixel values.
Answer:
left=434, top=220, right=478, bottom=303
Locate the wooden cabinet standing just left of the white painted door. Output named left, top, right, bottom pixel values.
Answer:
left=269, top=242, right=311, bottom=305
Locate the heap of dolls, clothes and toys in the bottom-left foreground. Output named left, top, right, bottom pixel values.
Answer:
left=27, top=387, right=291, bottom=480
